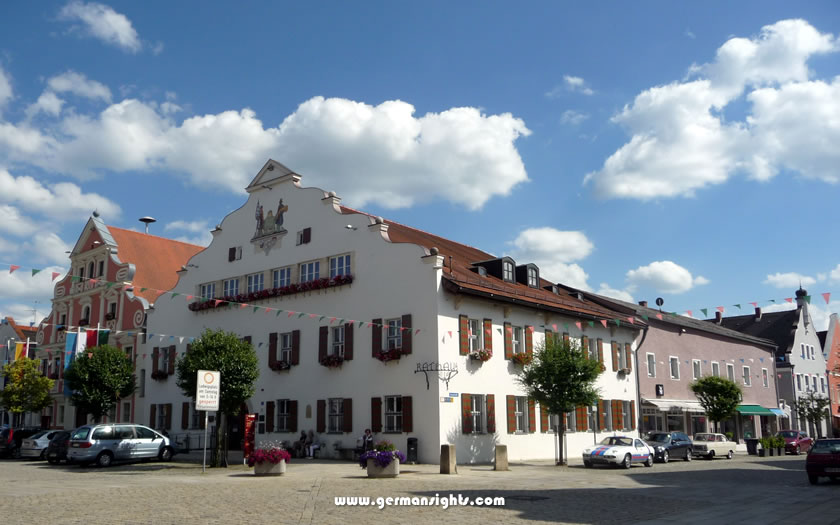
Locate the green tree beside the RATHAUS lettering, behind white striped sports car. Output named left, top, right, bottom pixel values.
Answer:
left=518, top=337, right=603, bottom=465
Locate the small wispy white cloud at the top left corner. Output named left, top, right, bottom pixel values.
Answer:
left=59, top=1, right=143, bottom=53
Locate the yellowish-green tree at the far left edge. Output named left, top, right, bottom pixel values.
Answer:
left=0, top=357, right=54, bottom=426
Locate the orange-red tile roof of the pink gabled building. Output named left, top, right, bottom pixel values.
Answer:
left=108, top=226, right=204, bottom=303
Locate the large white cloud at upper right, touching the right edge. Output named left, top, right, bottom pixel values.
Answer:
left=584, top=20, right=840, bottom=200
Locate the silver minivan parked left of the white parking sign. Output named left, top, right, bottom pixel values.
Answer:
left=67, top=423, right=175, bottom=467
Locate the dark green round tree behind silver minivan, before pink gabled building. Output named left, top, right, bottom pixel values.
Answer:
left=64, top=345, right=137, bottom=423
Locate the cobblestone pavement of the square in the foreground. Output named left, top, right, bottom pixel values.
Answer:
left=0, top=450, right=840, bottom=525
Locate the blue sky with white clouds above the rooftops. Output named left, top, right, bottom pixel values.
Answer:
left=0, top=1, right=840, bottom=325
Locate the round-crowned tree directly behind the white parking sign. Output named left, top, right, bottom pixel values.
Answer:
left=177, top=329, right=260, bottom=467
